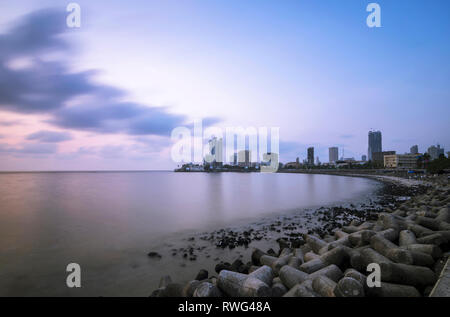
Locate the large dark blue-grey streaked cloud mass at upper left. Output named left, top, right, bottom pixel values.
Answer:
left=0, top=9, right=218, bottom=142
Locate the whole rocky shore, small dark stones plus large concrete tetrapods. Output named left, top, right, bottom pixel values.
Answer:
left=149, top=175, right=450, bottom=297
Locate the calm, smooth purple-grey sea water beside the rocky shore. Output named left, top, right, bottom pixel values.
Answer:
left=0, top=172, right=377, bottom=296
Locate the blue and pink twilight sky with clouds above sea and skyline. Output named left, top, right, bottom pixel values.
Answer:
left=0, top=0, right=450, bottom=171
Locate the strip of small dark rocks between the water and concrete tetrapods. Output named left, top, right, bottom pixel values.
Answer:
left=149, top=173, right=450, bottom=296
